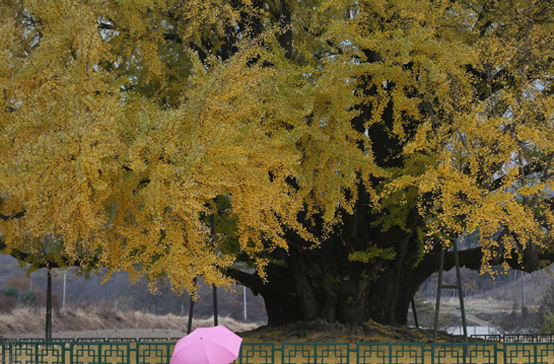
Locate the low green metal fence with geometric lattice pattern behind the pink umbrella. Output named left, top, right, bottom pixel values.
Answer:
left=0, top=341, right=554, bottom=364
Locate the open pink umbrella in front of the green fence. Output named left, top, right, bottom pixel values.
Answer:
left=169, top=326, right=242, bottom=364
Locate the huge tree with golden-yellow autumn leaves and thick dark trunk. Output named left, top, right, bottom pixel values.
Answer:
left=0, top=0, right=554, bottom=323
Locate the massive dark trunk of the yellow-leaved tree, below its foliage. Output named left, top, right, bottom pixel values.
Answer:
left=226, top=222, right=494, bottom=326
